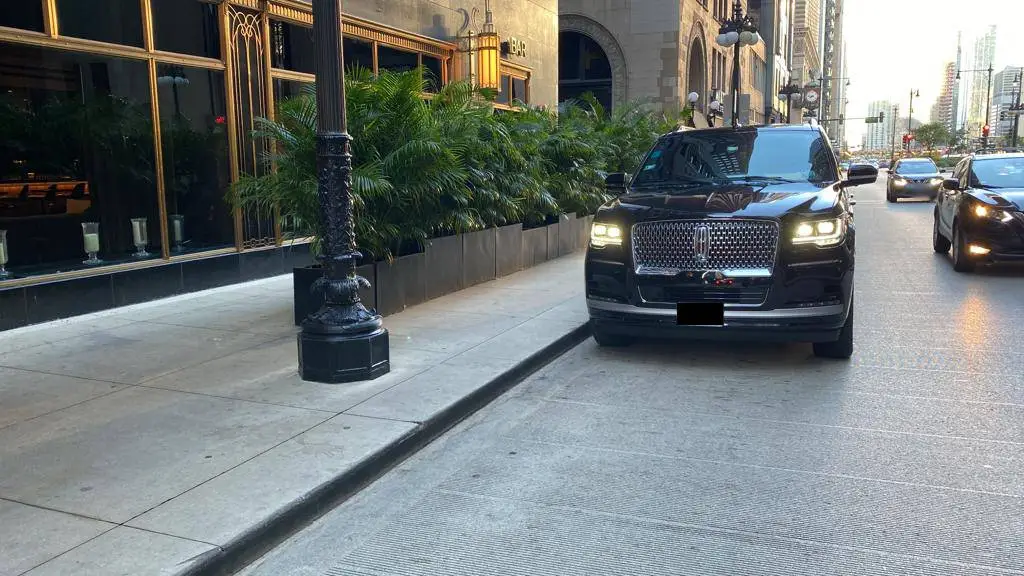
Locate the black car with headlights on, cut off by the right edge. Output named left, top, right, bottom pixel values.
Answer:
left=932, top=154, right=1024, bottom=272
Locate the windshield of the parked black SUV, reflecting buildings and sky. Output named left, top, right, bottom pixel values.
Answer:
left=633, top=129, right=839, bottom=187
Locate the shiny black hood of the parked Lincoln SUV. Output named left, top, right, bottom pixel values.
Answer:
left=607, top=183, right=839, bottom=219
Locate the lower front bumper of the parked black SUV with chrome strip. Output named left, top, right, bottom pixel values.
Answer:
left=587, top=298, right=849, bottom=342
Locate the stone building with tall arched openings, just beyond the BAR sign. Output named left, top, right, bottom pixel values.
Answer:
left=558, top=0, right=766, bottom=123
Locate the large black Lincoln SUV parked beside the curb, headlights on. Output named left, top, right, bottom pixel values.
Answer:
left=585, top=125, right=878, bottom=358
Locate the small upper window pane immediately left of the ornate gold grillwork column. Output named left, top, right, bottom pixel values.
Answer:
left=150, top=0, right=220, bottom=59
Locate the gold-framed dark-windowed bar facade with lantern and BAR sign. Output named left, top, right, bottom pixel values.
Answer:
left=0, top=0, right=558, bottom=329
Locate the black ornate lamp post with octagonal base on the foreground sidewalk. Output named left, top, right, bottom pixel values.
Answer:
left=298, top=0, right=391, bottom=383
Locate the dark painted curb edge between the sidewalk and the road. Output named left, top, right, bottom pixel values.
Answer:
left=175, top=322, right=591, bottom=576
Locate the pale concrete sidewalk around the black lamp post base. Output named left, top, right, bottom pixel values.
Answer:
left=0, top=253, right=587, bottom=576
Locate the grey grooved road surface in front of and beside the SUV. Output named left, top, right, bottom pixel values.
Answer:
left=241, top=174, right=1024, bottom=576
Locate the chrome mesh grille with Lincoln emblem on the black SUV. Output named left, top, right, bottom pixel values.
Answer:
left=633, top=219, right=779, bottom=274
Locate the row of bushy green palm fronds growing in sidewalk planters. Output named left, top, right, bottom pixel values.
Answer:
left=231, top=70, right=663, bottom=259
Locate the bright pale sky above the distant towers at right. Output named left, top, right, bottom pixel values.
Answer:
left=843, top=0, right=1024, bottom=146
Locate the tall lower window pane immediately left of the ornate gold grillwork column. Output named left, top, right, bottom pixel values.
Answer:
left=157, top=65, right=234, bottom=255
